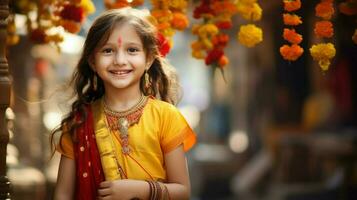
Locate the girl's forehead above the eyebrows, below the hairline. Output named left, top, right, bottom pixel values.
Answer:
left=107, top=23, right=142, bottom=44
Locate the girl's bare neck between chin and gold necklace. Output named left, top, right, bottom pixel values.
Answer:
left=104, top=88, right=142, bottom=111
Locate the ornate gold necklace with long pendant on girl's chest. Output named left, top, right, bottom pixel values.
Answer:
left=103, top=95, right=148, bottom=154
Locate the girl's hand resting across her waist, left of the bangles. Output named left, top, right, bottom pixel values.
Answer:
left=98, top=179, right=137, bottom=200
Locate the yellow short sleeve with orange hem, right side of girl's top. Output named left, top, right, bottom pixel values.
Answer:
left=160, top=104, right=196, bottom=153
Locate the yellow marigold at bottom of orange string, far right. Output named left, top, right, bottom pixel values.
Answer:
left=310, top=43, right=336, bottom=71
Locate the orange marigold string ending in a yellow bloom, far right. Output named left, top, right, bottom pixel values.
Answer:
left=310, top=0, right=336, bottom=71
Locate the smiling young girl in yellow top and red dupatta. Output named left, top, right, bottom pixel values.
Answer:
left=52, top=8, right=196, bottom=199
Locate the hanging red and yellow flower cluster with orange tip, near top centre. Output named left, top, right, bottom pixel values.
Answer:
left=191, top=0, right=237, bottom=71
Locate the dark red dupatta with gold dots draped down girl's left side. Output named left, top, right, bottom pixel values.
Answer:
left=73, top=105, right=104, bottom=200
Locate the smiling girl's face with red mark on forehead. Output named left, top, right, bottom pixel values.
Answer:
left=92, top=24, right=150, bottom=94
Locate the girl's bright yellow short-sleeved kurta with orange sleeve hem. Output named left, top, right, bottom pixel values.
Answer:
left=57, top=98, right=196, bottom=180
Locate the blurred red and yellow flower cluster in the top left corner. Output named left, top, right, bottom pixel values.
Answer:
left=8, top=0, right=95, bottom=49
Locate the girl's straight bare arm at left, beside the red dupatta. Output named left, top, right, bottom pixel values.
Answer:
left=54, top=155, right=76, bottom=200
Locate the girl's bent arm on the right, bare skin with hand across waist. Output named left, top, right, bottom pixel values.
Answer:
left=98, top=145, right=190, bottom=200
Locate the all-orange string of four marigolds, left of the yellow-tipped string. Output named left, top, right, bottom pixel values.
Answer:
left=279, top=0, right=304, bottom=61
